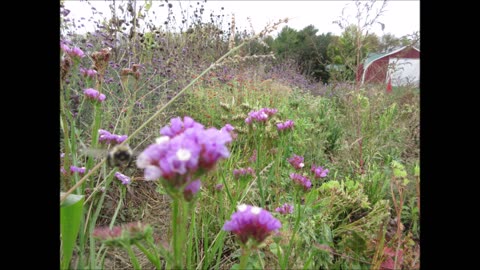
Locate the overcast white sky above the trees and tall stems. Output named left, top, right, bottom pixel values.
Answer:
left=65, top=0, right=420, bottom=37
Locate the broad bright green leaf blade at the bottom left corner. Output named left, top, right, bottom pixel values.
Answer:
left=60, top=194, right=84, bottom=269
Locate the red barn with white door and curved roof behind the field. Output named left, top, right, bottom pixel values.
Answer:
left=357, top=46, right=420, bottom=86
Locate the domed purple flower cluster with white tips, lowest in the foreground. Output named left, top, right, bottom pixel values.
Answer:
left=223, top=204, right=282, bottom=244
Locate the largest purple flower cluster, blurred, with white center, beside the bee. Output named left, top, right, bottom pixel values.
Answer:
left=137, top=116, right=232, bottom=187
